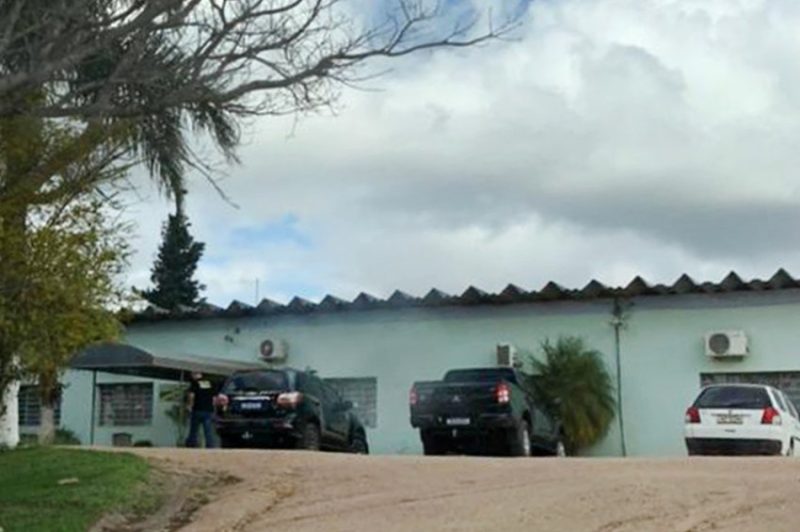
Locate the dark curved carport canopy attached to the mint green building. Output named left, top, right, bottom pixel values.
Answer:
left=70, top=343, right=267, bottom=381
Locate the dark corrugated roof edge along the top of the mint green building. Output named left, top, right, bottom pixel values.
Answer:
left=134, top=268, right=800, bottom=321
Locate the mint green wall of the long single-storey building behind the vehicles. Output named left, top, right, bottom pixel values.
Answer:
left=20, top=270, right=800, bottom=456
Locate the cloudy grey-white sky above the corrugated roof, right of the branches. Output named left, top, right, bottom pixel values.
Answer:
left=123, top=0, right=800, bottom=305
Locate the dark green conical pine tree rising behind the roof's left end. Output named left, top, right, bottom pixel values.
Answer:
left=141, top=194, right=205, bottom=310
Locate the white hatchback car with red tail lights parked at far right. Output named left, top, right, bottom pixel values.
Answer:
left=684, top=384, right=800, bottom=456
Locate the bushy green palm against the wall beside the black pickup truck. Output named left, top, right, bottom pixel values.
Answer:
left=531, top=336, right=616, bottom=452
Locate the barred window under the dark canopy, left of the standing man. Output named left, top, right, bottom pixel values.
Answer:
left=98, top=383, right=153, bottom=427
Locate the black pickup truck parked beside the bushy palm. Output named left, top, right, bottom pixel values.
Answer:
left=409, top=367, right=565, bottom=456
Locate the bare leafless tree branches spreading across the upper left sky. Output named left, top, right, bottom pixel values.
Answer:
left=0, top=0, right=515, bottom=118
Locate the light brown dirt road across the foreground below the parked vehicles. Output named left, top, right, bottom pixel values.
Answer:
left=130, top=449, right=800, bottom=532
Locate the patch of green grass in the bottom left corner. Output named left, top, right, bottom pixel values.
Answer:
left=0, top=447, right=160, bottom=532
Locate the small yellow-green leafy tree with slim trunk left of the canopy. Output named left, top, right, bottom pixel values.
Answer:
left=19, top=198, right=128, bottom=443
